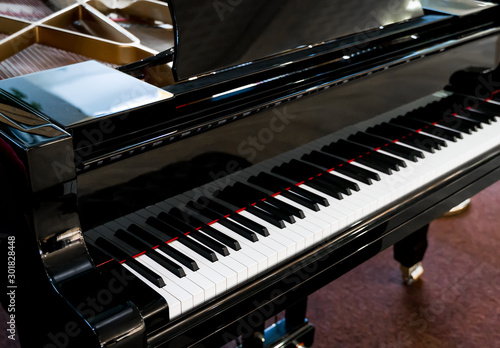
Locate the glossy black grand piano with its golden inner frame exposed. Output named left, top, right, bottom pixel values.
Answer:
left=0, top=0, right=500, bottom=348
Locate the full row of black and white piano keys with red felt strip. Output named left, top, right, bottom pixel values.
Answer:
left=85, top=90, right=500, bottom=319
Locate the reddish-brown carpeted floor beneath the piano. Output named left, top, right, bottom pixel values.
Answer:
left=308, top=183, right=500, bottom=348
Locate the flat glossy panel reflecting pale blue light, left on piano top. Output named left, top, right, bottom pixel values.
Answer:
left=0, top=61, right=172, bottom=128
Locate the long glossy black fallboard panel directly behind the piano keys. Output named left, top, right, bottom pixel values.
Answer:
left=78, top=27, right=500, bottom=231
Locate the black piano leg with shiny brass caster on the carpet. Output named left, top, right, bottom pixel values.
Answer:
left=394, top=225, right=429, bottom=285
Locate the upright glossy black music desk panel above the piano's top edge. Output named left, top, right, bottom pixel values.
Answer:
left=167, top=0, right=424, bottom=80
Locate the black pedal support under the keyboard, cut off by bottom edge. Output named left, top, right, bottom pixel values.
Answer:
left=241, top=297, right=314, bottom=348
